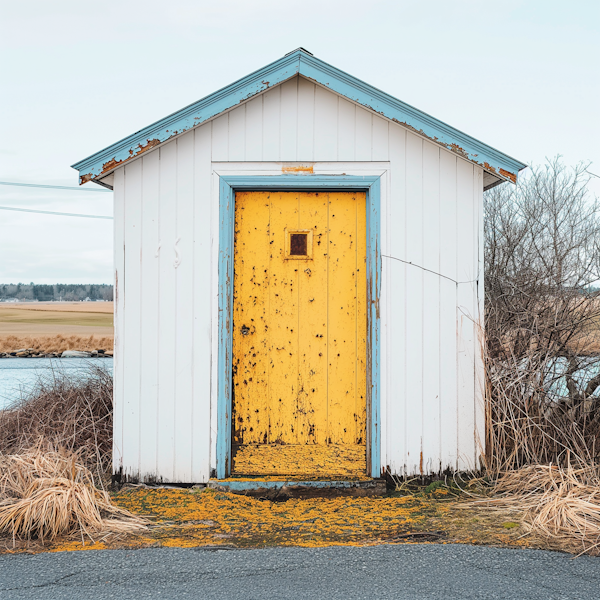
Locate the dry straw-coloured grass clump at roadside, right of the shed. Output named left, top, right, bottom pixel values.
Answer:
left=472, top=465, right=600, bottom=554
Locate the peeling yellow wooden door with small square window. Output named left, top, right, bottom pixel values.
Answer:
left=232, top=192, right=367, bottom=477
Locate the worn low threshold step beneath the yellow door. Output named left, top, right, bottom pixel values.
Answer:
left=208, top=477, right=387, bottom=500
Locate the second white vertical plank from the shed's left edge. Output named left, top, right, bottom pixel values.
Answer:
left=122, top=160, right=142, bottom=478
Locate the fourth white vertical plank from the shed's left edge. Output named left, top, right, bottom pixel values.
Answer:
left=156, top=140, right=177, bottom=481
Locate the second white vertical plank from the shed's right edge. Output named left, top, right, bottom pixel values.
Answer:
left=456, top=160, right=477, bottom=470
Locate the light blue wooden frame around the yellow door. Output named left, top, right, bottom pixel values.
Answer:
left=216, top=175, right=381, bottom=479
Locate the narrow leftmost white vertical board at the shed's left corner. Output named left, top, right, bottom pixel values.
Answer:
left=113, top=167, right=125, bottom=473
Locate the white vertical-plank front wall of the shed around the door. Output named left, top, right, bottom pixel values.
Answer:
left=114, top=78, right=484, bottom=482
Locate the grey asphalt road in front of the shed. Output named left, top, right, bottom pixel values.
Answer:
left=0, top=545, right=600, bottom=600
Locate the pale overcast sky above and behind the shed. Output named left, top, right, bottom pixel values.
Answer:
left=0, top=0, right=600, bottom=283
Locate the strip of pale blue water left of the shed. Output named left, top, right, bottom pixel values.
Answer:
left=0, top=358, right=113, bottom=410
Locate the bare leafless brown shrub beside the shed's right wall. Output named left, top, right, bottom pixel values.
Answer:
left=484, top=157, right=600, bottom=470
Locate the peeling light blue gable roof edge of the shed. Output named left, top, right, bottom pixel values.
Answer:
left=72, top=48, right=527, bottom=187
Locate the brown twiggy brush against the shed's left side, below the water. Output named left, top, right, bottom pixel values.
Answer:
left=0, top=359, right=113, bottom=485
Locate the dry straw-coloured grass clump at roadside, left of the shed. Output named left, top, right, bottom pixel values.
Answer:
left=0, top=450, right=148, bottom=543
